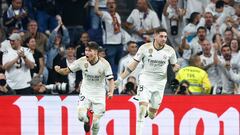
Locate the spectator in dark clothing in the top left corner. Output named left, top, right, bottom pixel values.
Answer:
left=3, top=0, right=29, bottom=30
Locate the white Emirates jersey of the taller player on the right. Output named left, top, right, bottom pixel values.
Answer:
left=134, top=42, right=177, bottom=84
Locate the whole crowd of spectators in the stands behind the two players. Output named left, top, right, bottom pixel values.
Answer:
left=0, top=0, right=240, bottom=95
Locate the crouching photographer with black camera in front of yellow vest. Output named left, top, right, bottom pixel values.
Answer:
left=174, top=80, right=192, bottom=95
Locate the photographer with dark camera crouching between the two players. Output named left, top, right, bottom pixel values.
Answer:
left=121, top=76, right=137, bottom=95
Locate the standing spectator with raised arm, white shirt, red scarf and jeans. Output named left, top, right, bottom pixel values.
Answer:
left=95, top=0, right=123, bottom=78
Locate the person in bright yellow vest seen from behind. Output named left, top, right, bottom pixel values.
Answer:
left=176, top=55, right=211, bottom=95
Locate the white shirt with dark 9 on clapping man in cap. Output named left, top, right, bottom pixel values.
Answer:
left=3, top=47, right=35, bottom=89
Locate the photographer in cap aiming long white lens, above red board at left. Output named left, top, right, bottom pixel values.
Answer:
left=28, top=76, right=68, bottom=95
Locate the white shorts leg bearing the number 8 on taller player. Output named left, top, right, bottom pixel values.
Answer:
left=137, top=85, right=151, bottom=103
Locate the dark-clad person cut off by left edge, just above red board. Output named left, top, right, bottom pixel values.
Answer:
left=0, top=73, right=15, bottom=95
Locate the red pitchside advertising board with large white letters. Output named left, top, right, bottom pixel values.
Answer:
left=0, top=96, right=240, bottom=135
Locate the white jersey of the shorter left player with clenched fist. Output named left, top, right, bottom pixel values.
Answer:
left=68, top=56, right=113, bottom=98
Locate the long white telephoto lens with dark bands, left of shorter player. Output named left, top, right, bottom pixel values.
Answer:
left=45, top=83, right=69, bottom=94
